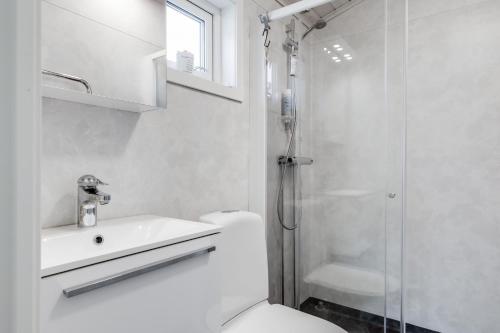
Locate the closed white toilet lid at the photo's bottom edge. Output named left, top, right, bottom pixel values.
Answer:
left=222, top=301, right=347, bottom=333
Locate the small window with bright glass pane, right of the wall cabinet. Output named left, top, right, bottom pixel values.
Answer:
left=167, top=0, right=217, bottom=80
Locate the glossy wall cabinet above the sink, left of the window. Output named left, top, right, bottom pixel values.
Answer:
left=41, top=0, right=167, bottom=112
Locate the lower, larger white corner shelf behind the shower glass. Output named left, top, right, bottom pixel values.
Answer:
left=304, top=263, right=399, bottom=296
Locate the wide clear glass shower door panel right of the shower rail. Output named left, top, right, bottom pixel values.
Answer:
left=299, top=1, right=404, bottom=332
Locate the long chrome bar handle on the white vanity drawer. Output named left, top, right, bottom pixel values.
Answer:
left=63, top=246, right=215, bottom=298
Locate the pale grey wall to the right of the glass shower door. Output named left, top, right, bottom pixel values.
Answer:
left=407, top=0, right=500, bottom=333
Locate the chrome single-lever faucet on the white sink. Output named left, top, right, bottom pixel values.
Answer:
left=77, top=175, right=111, bottom=228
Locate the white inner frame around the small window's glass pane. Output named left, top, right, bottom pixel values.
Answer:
left=165, top=0, right=220, bottom=81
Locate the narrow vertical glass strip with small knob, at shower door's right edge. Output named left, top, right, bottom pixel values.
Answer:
left=386, top=0, right=406, bottom=332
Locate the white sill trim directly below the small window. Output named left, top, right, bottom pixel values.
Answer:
left=167, top=68, right=243, bottom=103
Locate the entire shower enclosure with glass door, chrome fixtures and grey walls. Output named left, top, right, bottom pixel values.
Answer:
left=261, top=0, right=500, bottom=333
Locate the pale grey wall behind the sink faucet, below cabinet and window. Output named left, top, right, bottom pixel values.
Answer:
left=42, top=86, right=248, bottom=227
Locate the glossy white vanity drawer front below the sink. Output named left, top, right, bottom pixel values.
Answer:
left=41, top=236, right=220, bottom=333
